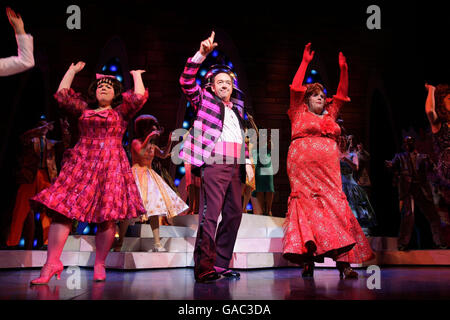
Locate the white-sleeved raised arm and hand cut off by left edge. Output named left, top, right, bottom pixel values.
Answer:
left=0, top=8, right=34, bottom=76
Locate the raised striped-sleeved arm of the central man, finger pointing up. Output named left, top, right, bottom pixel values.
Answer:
left=180, top=31, right=218, bottom=109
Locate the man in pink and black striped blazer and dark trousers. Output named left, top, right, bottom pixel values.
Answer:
left=180, top=32, right=245, bottom=282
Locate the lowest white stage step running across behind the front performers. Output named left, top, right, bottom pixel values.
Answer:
left=0, top=250, right=450, bottom=270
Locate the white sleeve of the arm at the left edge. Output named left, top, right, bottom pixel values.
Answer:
left=0, top=34, right=34, bottom=76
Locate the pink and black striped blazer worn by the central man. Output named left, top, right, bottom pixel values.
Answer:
left=179, top=58, right=244, bottom=167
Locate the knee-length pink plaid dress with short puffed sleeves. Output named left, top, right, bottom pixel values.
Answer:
left=30, top=89, right=148, bottom=223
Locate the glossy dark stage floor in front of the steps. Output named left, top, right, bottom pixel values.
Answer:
left=0, top=267, right=450, bottom=300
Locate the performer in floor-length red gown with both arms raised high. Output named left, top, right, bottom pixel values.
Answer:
left=283, top=43, right=374, bottom=278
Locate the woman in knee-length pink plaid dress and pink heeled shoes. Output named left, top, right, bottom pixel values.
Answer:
left=30, top=62, right=148, bottom=284
